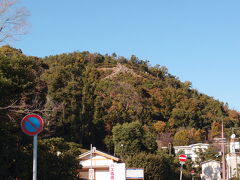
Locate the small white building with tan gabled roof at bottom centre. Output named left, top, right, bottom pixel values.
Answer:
left=78, top=147, right=126, bottom=180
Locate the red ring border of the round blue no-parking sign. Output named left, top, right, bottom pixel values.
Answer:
left=21, top=114, right=44, bottom=136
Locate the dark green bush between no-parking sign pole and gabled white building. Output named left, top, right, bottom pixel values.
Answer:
left=38, top=138, right=81, bottom=180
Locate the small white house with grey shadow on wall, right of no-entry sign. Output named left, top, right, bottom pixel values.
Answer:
left=201, top=160, right=221, bottom=180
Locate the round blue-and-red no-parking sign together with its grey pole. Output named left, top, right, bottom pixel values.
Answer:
left=21, top=114, right=43, bottom=180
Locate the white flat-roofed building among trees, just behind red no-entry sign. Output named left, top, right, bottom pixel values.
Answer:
left=174, top=143, right=209, bottom=161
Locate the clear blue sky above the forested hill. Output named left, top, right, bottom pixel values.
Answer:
left=7, top=0, right=240, bottom=111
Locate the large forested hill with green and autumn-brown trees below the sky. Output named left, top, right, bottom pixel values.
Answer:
left=0, top=46, right=240, bottom=152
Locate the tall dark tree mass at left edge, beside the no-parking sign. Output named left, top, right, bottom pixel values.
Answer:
left=0, top=46, right=45, bottom=179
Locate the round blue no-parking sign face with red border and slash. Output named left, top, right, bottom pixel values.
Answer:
left=21, top=114, right=44, bottom=136
